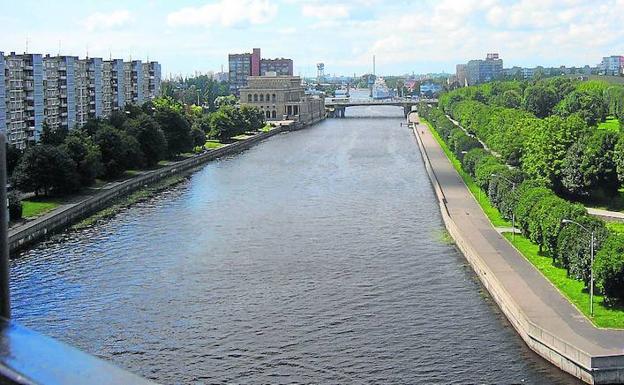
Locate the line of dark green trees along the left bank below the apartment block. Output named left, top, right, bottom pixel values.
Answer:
left=7, top=97, right=265, bottom=219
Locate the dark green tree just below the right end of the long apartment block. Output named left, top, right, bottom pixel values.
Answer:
left=126, top=114, right=168, bottom=167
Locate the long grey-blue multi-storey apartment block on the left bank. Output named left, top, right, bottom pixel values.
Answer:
left=0, top=52, right=161, bottom=149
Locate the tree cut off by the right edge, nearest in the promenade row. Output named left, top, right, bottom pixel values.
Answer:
left=594, top=234, right=624, bottom=302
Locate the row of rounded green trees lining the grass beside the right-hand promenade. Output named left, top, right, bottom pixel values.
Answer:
left=418, top=104, right=624, bottom=304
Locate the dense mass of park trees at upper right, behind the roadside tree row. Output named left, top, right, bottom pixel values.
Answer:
left=440, top=77, right=624, bottom=201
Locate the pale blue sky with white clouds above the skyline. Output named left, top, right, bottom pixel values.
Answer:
left=0, top=0, right=624, bottom=76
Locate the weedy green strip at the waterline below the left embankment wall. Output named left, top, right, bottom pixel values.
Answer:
left=71, top=175, right=187, bottom=230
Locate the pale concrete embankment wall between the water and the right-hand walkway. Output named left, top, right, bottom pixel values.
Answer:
left=413, top=121, right=624, bottom=384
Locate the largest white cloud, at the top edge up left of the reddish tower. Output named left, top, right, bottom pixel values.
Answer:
left=167, top=0, right=277, bottom=27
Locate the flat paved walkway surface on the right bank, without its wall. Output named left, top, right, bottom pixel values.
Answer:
left=412, top=114, right=624, bottom=362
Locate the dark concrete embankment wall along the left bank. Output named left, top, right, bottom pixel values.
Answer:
left=9, top=122, right=308, bottom=252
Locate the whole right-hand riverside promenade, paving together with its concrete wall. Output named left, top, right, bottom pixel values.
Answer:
left=408, top=113, right=624, bottom=384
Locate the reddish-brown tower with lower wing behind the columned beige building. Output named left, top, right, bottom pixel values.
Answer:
left=228, top=48, right=293, bottom=93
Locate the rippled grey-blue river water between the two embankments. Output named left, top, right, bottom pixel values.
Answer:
left=11, top=107, right=576, bottom=384
